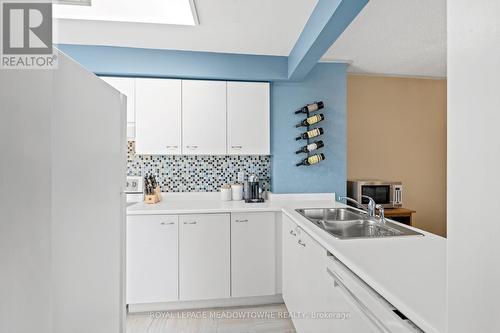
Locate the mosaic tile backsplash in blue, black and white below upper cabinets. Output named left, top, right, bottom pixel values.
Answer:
left=127, top=141, right=271, bottom=192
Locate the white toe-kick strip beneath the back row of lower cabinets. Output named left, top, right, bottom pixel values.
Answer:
left=128, top=294, right=283, bottom=313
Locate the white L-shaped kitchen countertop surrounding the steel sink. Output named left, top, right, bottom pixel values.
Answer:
left=127, top=193, right=446, bottom=333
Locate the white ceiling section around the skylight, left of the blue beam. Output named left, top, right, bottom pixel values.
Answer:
left=54, top=0, right=317, bottom=56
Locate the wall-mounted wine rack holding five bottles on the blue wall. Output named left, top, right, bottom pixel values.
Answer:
left=295, top=101, right=325, bottom=166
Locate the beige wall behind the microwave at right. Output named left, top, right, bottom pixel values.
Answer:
left=347, top=75, right=446, bottom=236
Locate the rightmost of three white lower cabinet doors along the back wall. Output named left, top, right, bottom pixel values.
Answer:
left=231, top=213, right=276, bottom=297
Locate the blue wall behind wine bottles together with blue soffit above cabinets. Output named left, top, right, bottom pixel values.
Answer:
left=58, top=45, right=347, bottom=195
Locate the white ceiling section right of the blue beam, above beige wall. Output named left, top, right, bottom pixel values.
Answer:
left=322, top=0, right=446, bottom=77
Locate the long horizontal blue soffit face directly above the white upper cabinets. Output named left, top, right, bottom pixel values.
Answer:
left=57, top=44, right=288, bottom=81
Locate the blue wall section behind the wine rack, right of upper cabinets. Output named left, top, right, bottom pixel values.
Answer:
left=271, top=63, right=347, bottom=195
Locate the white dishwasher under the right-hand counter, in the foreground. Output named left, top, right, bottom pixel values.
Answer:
left=327, top=254, right=423, bottom=333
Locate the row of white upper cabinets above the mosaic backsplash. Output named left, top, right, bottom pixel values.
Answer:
left=102, top=76, right=270, bottom=155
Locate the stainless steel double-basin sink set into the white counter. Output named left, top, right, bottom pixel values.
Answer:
left=297, top=208, right=423, bottom=239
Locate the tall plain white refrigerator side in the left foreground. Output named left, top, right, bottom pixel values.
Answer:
left=51, top=54, right=126, bottom=333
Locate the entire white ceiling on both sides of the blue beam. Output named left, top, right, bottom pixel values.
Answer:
left=54, top=0, right=446, bottom=77
